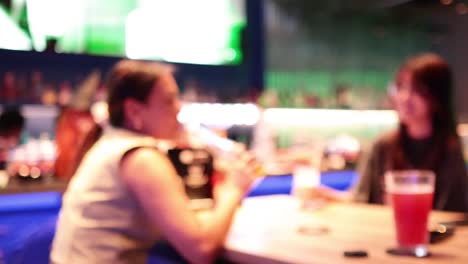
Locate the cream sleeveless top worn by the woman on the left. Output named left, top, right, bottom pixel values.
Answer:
left=51, top=127, right=168, bottom=264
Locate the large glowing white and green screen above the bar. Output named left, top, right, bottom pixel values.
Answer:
left=0, top=0, right=246, bottom=65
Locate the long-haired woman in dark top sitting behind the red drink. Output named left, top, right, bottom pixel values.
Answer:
left=354, top=53, right=468, bottom=212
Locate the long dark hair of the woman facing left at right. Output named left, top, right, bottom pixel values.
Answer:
left=392, top=53, right=459, bottom=169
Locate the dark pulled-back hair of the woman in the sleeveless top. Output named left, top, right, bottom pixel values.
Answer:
left=106, top=60, right=172, bottom=127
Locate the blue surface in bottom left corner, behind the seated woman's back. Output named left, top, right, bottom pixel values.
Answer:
left=0, top=192, right=61, bottom=264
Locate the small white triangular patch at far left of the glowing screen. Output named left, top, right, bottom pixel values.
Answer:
left=0, top=6, right=31, bottom=50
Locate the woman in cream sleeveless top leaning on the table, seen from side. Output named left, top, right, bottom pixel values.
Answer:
left=51, top=60, right=253, bottom=264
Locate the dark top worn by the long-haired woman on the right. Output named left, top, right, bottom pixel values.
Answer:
left=354, top=132, right=468, bottom=212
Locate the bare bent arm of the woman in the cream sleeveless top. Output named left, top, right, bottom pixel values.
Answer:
left=120, top=148, right=250, bottom=263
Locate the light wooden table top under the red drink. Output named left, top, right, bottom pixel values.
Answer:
left=225, top=195, right=468, bottom=264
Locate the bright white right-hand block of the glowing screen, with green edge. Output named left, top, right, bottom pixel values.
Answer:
left=126, top=0, right=245, bottom=64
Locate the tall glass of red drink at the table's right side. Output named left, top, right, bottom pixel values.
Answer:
left=385, top=170, right=435, bottom=257
